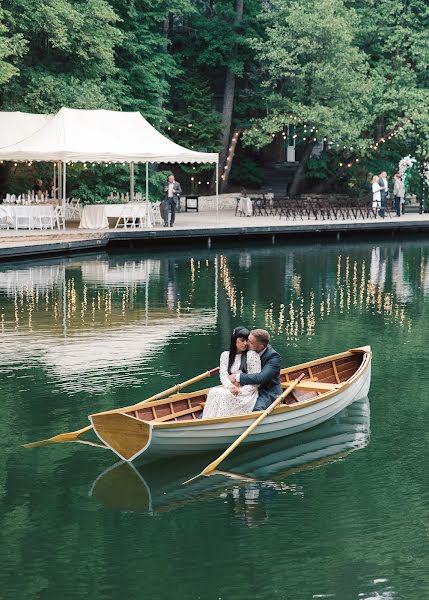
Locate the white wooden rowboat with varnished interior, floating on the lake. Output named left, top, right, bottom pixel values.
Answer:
left=89, top=346, right=371, bottom=462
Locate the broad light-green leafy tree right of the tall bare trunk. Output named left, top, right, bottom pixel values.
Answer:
left=246, top=0, right=375, bottom=195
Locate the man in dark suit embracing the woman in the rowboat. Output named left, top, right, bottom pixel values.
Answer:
left=229, top=329, right=283, bottom=411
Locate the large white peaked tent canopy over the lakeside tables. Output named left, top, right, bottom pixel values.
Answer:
left=0, top=108, right=218, bottom=163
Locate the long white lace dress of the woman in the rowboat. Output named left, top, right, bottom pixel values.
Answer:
left=202, top=350, right=261, bottom=419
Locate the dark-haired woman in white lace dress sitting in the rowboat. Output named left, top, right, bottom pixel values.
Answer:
left=202, top=327, right=261, bottom=419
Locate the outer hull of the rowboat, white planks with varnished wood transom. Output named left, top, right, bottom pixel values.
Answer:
left=90, top=348, right=371, bottom=462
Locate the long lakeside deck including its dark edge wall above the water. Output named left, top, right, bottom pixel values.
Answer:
left=0, top=210, right=429, bottom=261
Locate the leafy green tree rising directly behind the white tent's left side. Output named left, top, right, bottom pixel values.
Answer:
left=0, top=0, right=123, bottom=112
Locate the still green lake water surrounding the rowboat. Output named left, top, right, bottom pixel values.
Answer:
left=0, top=240, right=429, bottom=600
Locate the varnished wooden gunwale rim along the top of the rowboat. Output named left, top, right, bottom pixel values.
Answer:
left=152, top=347, right=371, bottom=429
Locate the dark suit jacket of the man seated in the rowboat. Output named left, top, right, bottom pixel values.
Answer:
left=240, top=344, right=282, bottom=411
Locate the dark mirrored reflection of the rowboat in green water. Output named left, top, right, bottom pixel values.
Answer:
left=89, top=398, right=370, bottom=525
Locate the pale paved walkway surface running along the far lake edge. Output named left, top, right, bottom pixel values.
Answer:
left=0, top=210, right=429, bottom=259
